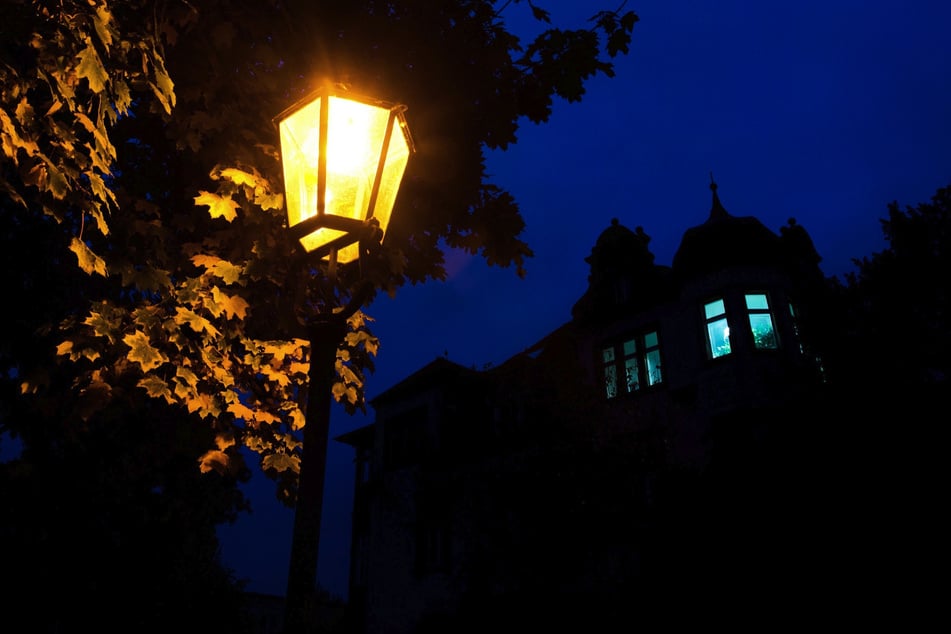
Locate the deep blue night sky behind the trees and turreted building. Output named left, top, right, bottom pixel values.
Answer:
left=222, top=0, right=951, bottom=597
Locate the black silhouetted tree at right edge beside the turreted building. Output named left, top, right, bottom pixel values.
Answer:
left=817, top=180, right=951, bottom=607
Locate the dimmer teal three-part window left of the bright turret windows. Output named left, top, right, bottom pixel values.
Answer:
left=601, top=331, right=663, bottom=398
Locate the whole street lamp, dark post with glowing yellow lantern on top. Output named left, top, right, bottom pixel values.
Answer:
left=275, top=87, right=414, bottom=634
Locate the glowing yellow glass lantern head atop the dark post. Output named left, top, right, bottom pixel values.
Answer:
left=279, top=87, right=413, bottom=263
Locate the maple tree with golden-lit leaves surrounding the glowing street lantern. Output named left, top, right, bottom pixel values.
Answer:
left=0, top=0, right=637, bottom=500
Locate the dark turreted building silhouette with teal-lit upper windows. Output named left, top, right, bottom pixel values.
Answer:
left=337, top=184, right=826, bottom=634
